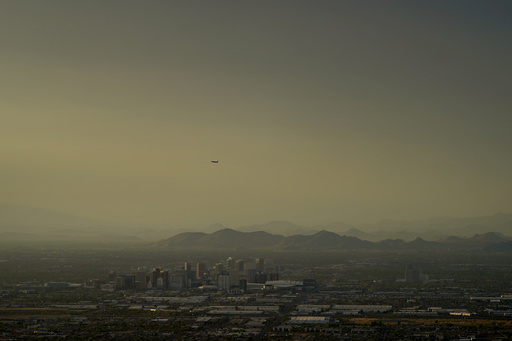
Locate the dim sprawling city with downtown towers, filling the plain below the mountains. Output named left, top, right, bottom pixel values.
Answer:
left=0, top=246, right=512, bottom=340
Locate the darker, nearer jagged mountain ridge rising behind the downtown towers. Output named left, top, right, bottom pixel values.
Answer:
left=156, top=229, right=512, bottom=251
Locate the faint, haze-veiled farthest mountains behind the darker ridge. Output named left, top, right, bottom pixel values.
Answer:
left=0, top=204, right=512, bottom=243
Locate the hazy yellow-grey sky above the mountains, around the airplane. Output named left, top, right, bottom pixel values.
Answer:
left=0, top=0, right=512, bottom=227
